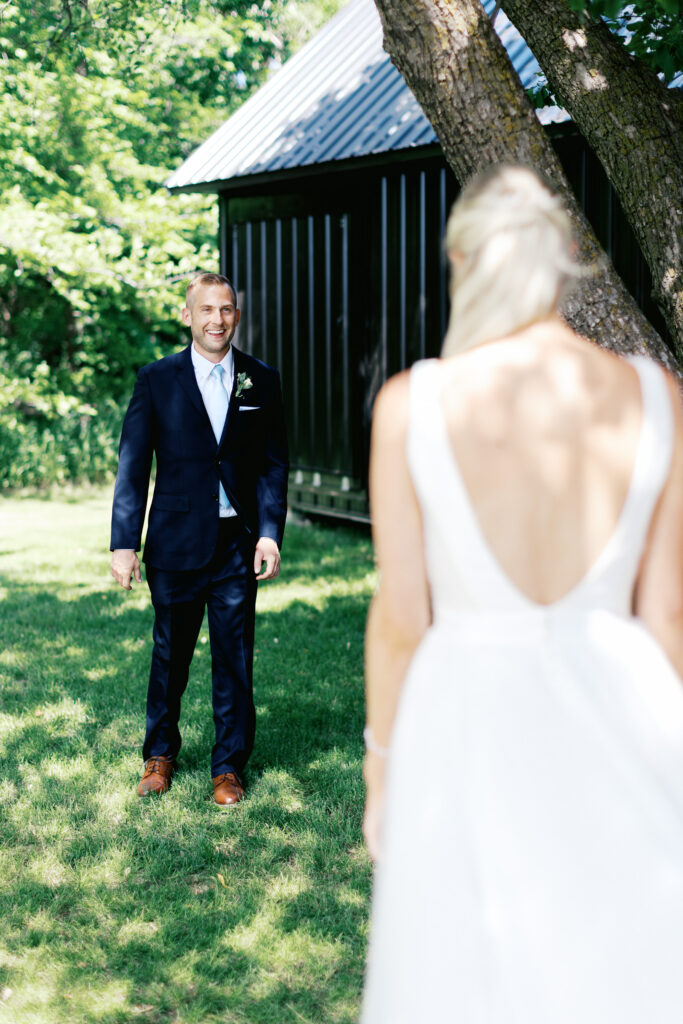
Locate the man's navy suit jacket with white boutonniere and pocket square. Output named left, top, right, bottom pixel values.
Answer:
left=111, top=345, right=289, bottom=570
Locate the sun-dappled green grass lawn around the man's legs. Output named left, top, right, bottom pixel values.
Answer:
left=0, top=492, right=375, bottom=1024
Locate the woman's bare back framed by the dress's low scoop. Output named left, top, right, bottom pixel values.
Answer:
left=441, top=319, right=655, bottom=604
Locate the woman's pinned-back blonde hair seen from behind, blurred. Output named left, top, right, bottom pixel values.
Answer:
left=441, top=167, right=582, bottom=355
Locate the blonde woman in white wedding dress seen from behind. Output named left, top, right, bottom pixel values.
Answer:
left=361, top=167, right=683, bottom=1024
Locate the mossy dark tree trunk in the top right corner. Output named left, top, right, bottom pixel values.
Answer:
left=503, top=0, right=683, bottom=360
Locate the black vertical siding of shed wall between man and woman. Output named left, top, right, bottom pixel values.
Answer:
left=220, top=163, right=456, bottom=499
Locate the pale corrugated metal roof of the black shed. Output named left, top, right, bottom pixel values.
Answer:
left=166, top=0, right=567, bottom=189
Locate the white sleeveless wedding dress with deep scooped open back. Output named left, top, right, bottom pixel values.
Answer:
left=361, top=358, right=683, bottom=1024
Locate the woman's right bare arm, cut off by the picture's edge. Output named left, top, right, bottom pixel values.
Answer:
left=636, top=380, right=683, bottom=679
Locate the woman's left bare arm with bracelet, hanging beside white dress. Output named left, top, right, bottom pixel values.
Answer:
left=364, top=374, right=431, bottom=859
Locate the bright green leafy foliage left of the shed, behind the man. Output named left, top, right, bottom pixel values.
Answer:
left=0, top=0, right=341, bottom=489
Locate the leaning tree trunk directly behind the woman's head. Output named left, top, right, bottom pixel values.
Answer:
left=375, top=0, right=675, bottom=369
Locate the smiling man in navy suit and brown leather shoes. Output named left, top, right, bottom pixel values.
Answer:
left=111, top=273, right=288, bottom=806
